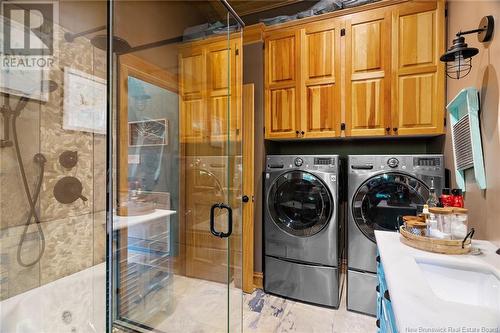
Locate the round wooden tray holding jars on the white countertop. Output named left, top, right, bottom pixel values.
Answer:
left=399, top=226, right=471, bottom=254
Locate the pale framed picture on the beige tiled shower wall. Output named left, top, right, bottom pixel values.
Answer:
left=63, top=67, right=106, bottom=134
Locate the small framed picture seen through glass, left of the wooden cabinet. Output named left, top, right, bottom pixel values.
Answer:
left=128, top=119, right=168, bottom=147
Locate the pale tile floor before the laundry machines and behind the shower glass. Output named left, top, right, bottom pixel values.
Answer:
left=145, top=276, right=376, bottom=333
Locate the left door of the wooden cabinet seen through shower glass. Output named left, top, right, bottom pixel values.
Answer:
left=179, top=48, right=208, bottom=142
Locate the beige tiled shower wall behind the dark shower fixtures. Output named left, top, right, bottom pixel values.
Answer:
left=0, top=17, right=106, bottom=300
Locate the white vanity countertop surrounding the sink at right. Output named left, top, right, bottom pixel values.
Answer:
left=375, top=231, right=500, bottom=332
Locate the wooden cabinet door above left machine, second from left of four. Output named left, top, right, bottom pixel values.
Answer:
left=300, top=20, right=341, bottom=138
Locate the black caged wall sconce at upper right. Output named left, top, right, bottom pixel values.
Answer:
left=439, top=15, right=495, bottom=80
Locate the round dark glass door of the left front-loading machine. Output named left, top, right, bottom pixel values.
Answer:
left=267, top=170, right=334, bottom=237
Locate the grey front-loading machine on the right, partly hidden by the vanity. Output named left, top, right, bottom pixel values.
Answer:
left=347, top=155, right=444, bottom=315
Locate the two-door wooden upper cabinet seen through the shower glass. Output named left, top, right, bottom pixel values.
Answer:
left=179, top=37, right=243, bottom=142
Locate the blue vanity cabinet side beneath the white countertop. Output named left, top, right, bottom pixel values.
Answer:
left=377, top=255, right=398, bottom=333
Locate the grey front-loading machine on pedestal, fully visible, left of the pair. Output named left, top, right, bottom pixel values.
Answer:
left=264, top=155, right=340, bottom=307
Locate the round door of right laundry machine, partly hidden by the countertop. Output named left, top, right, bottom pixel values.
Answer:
left=352, top=172, right=429, bottom=242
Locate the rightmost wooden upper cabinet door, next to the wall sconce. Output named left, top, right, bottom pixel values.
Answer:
left=392, top=1, right=445, bottom=135
